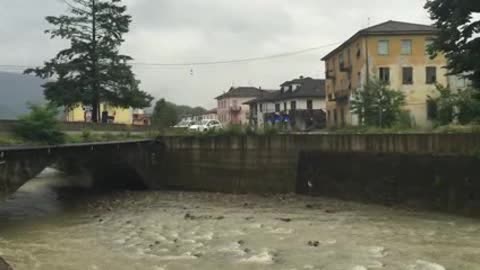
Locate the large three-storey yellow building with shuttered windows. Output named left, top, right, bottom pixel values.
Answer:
left=322, top=21, right=448, bottom=126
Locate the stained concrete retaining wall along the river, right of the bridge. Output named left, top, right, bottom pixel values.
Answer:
left=159, top=134, right=480, bottom=214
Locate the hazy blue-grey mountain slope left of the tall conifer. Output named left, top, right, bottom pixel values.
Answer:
left=0, top=72, right=44, bottom=119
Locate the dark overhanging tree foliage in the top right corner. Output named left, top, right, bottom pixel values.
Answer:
left=425, top=0, right=480, bottom=88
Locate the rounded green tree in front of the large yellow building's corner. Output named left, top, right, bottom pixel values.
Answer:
left=351, top=79, right=405, bottom=128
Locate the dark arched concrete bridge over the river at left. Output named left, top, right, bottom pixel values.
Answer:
left=0, top=140, right=164, bottom=198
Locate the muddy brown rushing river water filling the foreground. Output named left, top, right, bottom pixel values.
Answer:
left=0, top=171, right=480, bottom=270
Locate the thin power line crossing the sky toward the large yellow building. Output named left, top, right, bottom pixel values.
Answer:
left=0, top=42, right=340, bottom=69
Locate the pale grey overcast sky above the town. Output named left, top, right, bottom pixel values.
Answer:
left=0, top=0, right=430, bottom=108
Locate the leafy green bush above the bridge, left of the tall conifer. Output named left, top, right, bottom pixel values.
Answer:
left=14, top=105, right=65, bottom=144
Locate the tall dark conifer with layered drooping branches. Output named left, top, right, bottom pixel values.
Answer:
left=25, top=0, right=153, bottom=122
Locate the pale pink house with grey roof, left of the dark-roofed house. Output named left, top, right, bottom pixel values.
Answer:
left=216, top=87, right=266, bottom=125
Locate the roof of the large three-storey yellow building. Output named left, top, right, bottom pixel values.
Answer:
left=322, top=20, right=438, bottom=61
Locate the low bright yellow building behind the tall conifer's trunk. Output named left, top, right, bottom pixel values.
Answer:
left=65, top=103, right=133, bottom=125
